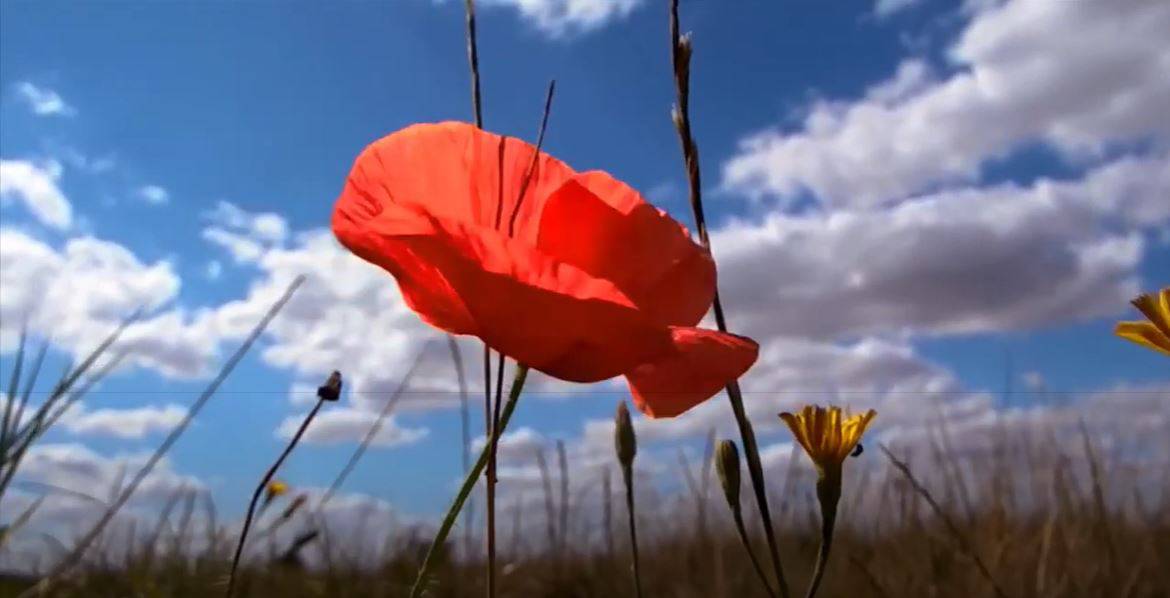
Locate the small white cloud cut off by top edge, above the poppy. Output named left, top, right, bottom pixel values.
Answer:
left=470, top=0, right=644, bottom=37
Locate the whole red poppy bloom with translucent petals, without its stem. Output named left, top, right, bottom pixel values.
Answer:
left=332, top=123, right=758, bottom=417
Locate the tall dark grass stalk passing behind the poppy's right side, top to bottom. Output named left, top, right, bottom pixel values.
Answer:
left=670, top=0, right=789, bottom=598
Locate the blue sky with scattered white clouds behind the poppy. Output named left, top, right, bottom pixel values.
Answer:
left=0, top=0, right=1170, bottom=552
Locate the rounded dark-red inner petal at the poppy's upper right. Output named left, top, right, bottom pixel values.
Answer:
left=537, top=171, right=715, bottom=327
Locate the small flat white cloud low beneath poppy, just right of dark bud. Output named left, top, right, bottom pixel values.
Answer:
left=276, top=405, right=431, bottom=447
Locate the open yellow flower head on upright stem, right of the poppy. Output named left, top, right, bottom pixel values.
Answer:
left=780, top=405, right=878, bottom=475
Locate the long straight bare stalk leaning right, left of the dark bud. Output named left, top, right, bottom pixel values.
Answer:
left=18, top=276, right=304, bottom=598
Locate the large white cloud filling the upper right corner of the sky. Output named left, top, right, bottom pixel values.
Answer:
left=722, top=0, right=1170, bottom=207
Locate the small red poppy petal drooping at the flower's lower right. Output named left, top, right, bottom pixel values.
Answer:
left=626, top=327, right=759, bottom=418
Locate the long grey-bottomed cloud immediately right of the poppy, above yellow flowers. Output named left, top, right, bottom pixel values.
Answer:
left=713, top=157, right=1170, bottom=338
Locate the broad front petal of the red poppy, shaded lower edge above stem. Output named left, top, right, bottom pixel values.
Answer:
left=335, top=197, right=670, bottom=383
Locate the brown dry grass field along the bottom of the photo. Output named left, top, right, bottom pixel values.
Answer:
left=0, top=430, right=1170, bottom=598
